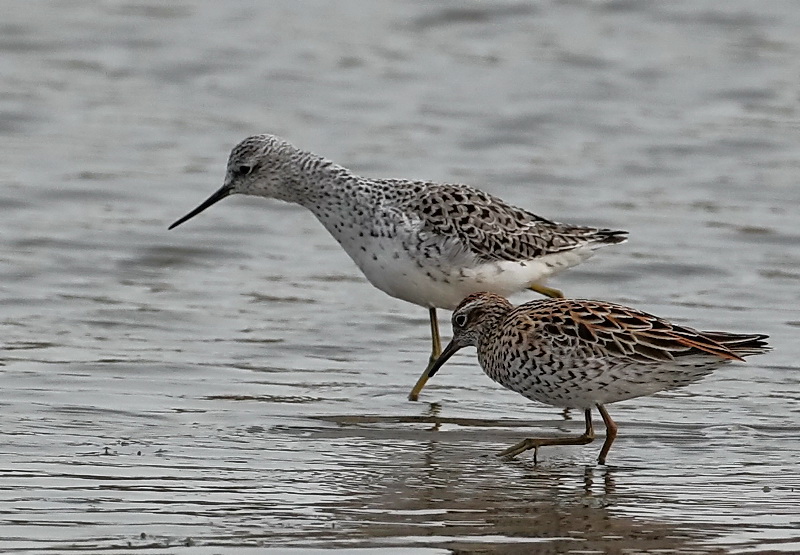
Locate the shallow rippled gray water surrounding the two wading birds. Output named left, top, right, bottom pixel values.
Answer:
left=0, top=0, right=800, bottom=554
